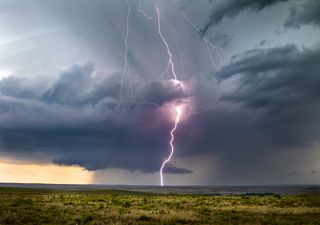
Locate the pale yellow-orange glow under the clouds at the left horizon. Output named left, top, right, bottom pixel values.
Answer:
left=0, top=160, right=94, bottom=184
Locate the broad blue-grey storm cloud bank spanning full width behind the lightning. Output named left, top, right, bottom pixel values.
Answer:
left=0, top=45, right=320, bottom=176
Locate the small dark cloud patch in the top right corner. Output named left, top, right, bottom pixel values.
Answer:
left=284, top=0, right=320, bottom=28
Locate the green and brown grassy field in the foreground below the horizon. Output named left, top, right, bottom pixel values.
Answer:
left=0, top=188, right=320, bottom=225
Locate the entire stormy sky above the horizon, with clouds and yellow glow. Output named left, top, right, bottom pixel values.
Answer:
left=0, top=0, right=320, bottom=185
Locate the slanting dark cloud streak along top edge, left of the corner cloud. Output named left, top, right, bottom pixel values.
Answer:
left=201, top=0, right=289, bottom=35
